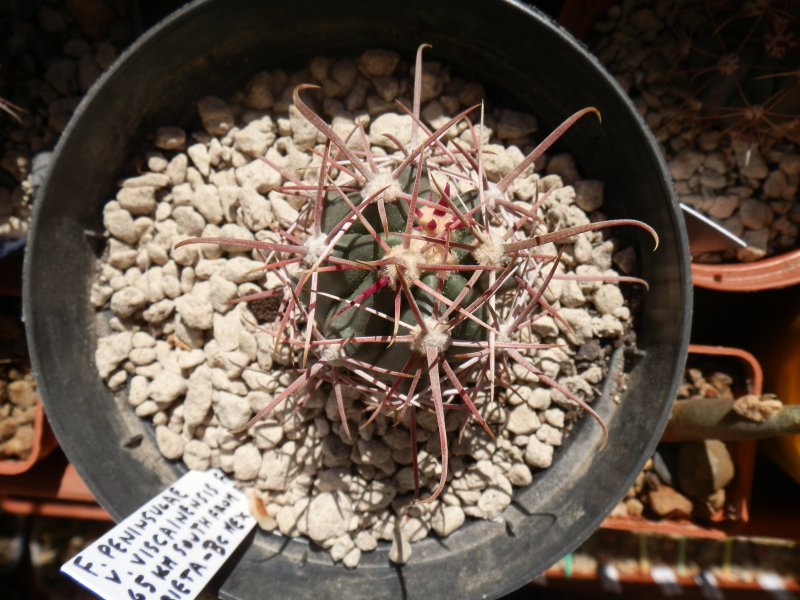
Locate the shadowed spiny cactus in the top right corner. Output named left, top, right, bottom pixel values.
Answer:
left=670, top=0, right=800, bottom=146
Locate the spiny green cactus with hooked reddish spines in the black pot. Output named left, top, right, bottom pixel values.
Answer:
left=178, top=46, right=658, bottom=502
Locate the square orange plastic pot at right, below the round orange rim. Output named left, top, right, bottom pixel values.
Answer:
left=602, top=344, right=764, bottom=539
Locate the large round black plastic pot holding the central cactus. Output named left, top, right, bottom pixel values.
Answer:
left=24, top=0, right=691, bottom=598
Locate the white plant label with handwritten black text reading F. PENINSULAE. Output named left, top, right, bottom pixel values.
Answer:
left=61, top=469, right=256, bottom=600
